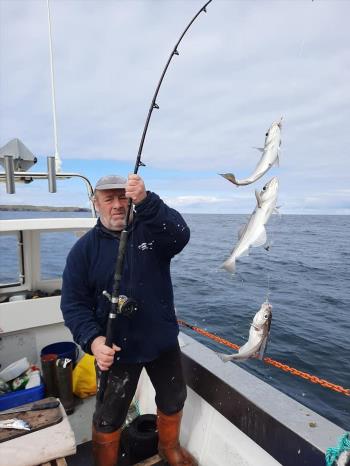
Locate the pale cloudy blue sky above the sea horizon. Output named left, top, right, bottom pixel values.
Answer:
left=0, top=0, right=350, bottom=214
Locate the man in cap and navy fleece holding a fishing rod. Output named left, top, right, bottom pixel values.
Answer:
left=61, top=175, right=197, bottom=466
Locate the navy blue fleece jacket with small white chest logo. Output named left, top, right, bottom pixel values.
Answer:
left=61, top=192, right=190, bottom=363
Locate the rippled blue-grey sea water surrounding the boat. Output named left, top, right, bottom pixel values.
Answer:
left=0, top=212, right=350, bottom=430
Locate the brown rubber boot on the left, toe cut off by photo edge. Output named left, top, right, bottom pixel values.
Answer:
left=92, top=427, right=121, bottom=466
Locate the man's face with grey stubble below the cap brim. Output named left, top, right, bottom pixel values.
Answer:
left=94, top=189, right=128, bottom=231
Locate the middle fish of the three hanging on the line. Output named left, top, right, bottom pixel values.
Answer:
left=222, top=177, right=278, bottom=273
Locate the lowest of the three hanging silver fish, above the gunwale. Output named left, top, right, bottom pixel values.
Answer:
left=216, top=302, right=272, bottom=362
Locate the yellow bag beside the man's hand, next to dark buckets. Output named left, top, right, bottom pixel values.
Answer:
left=73, top=354, right=97, bottom=398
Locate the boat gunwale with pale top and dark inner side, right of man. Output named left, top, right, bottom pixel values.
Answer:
left=181, top=334, right=344, bottom=466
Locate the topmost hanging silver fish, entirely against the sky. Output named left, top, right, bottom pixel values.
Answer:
left=220, top=118, right=282, bottom=186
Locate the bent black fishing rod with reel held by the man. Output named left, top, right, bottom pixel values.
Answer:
left=97, top=0, right=212, bottom=402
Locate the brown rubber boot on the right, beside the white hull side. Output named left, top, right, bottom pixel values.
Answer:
left=157, top=409, right=198, bottom=466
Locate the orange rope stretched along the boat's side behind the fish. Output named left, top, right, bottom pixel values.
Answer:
left=178, top=319, right=350, bottom=396
